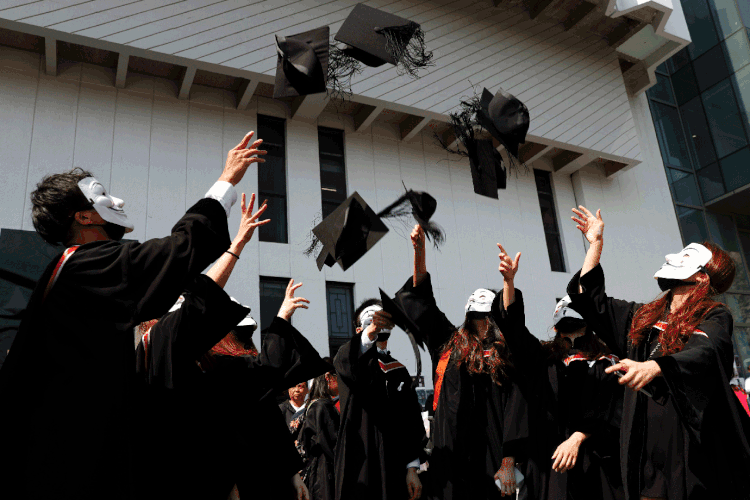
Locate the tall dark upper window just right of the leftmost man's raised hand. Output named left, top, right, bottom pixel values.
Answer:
left=258, top=115, right=288, bottom=243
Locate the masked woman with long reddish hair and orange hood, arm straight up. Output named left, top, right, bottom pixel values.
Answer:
left=396, top=225, right=528, bottom=500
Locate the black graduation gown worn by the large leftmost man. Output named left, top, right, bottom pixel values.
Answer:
left=0, top=199, right=230, bottom=499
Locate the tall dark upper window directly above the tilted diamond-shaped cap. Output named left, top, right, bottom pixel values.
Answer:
left=318, top=127, right=346, bottom=219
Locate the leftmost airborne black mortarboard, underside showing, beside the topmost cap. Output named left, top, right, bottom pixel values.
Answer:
left=273, top=26, right=330, bottom=99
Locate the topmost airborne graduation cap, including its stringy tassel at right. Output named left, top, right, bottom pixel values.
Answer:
left=334, top=3, right=432, bottom=77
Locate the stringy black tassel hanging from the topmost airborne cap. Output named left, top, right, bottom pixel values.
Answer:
left=375, top=21, right=435, bottom=78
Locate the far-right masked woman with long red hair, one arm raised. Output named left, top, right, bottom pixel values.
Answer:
left=568, top=207, right=750, bottom=500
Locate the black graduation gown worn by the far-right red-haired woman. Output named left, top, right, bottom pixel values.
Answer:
left=568, top=265, right=750, bottom=500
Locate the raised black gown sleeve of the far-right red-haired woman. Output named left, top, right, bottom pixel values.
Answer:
left=567, top=264, right=642, bottom=359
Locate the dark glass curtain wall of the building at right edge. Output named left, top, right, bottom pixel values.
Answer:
left=647, top=0, right=750, bottom=377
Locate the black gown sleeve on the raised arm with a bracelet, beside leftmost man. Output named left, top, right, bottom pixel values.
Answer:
left=136, top=274, right=249, bottom=389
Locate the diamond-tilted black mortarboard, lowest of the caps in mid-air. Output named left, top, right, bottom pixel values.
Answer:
left=311, top=191, right=388, bottom=271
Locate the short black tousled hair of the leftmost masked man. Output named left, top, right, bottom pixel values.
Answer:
left=31, top=167, right=93, bottom=245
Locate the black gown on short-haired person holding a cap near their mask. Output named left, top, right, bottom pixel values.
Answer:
left=333, top=335, right=426, bottom=500
